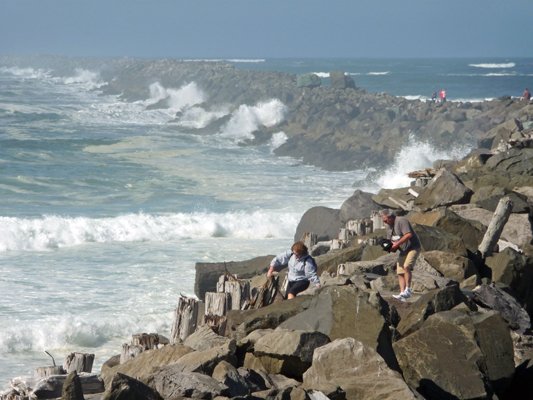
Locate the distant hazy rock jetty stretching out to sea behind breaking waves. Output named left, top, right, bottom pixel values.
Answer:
left=4, top=56, right=533, bottom=170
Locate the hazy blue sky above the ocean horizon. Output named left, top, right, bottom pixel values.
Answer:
left=0, top=0, right=533, bottom=58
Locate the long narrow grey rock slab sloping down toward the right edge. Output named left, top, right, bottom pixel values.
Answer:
left=473, top=284, right=531, bottom=334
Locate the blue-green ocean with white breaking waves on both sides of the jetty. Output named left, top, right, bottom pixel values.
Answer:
left=0, top=58, right=533, bottom=390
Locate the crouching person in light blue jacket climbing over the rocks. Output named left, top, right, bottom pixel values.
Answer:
left=267, top=242, right=320, bottom=300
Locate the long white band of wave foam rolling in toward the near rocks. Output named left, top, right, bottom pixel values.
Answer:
left=0, top=210, right=298, bottom=252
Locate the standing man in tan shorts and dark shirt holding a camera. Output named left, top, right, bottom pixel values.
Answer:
left=380, top=209, right=420, bottom=301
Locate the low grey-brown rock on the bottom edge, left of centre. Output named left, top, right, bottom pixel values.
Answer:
left=152, top=364, right=230, bottom=400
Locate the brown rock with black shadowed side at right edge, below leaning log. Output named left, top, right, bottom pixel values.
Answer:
left=485, top=247, right=533, bottom=315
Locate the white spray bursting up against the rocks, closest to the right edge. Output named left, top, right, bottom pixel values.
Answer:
left=376, top=137, right=471, bottom=189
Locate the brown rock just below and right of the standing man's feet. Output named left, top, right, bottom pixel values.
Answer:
left=398, top=285, right=468, bottom=337
